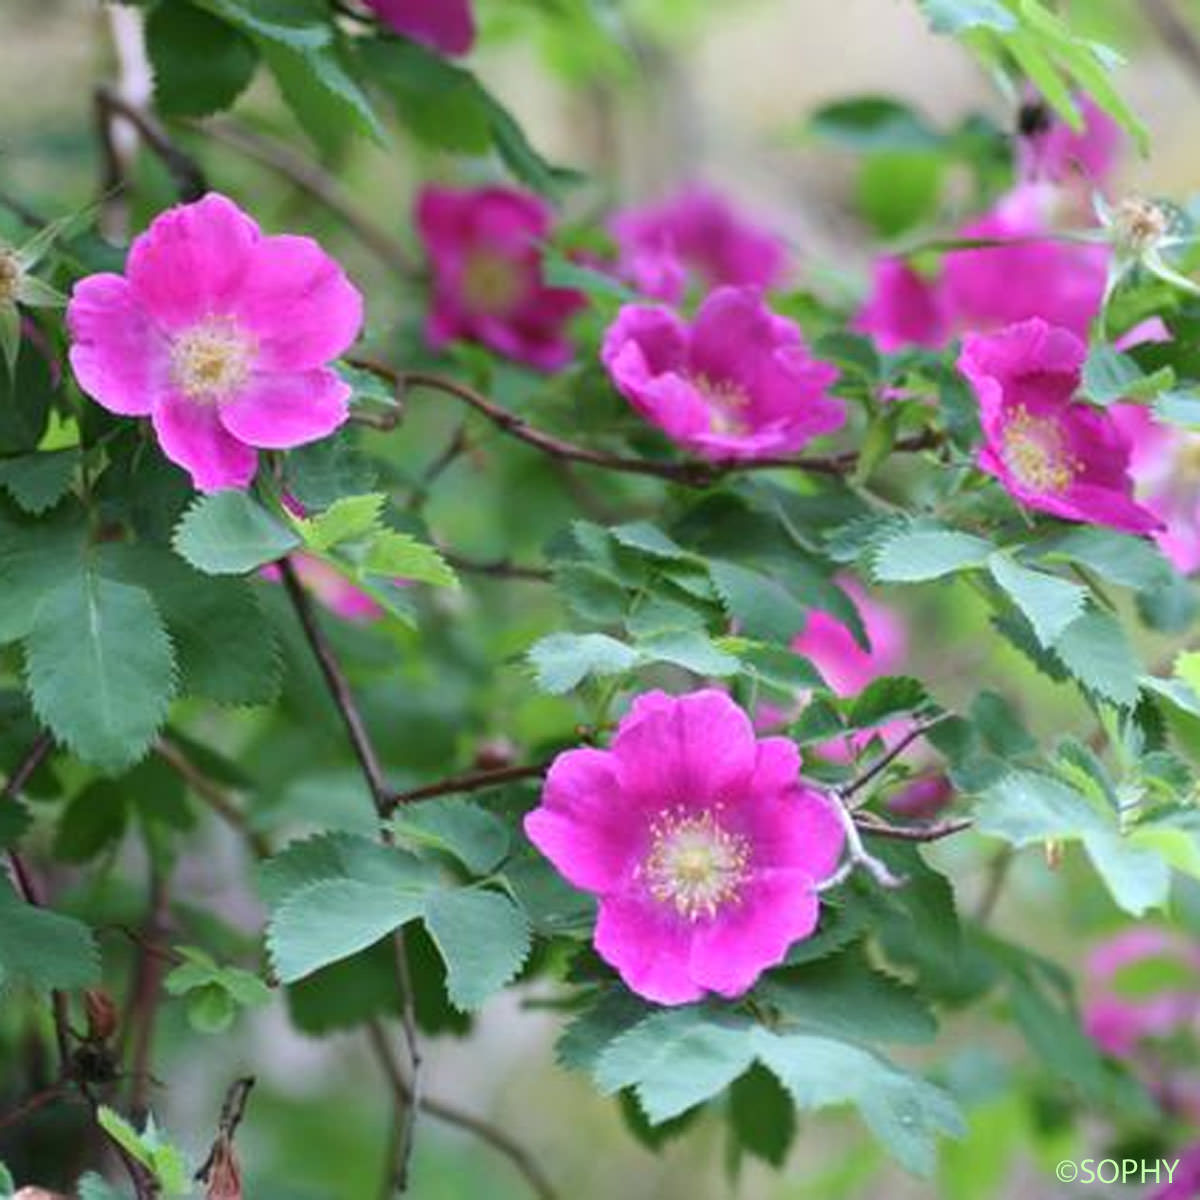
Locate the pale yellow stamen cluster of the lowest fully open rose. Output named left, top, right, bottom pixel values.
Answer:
left=637, top=809, right=750, bottom=920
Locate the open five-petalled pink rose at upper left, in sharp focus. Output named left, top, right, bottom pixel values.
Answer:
left=67, top=193, right=362, bottom=491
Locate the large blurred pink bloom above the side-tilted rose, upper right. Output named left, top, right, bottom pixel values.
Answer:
left=856, top=186, right=1109, bottom=353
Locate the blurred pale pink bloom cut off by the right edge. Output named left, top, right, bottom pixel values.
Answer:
left=1109, top=404, right=1200, bottom=575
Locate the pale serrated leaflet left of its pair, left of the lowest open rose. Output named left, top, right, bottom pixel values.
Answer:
left=266, top=880, right=425, bottom=983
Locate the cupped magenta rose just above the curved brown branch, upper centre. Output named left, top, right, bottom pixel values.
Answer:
left=601, top=288, right=846, bottom=462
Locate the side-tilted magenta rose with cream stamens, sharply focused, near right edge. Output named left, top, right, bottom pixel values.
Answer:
left=959, top=319, right=1159, bottom=533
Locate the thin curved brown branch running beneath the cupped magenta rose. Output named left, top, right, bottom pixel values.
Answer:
left=350, top=359, right=941, bottom=487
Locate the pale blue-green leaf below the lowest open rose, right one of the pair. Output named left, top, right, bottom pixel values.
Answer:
left=756, top=1030, right=966, bottom=1175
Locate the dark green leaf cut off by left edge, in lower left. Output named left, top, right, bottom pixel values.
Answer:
left=0, top=881, right=100, bottom=991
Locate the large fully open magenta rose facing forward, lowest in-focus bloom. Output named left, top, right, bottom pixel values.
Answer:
left=526, top=690, right=845, bottom=1004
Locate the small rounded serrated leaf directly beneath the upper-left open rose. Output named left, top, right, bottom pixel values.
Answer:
left=173, top=491, right=300, bottom=575
